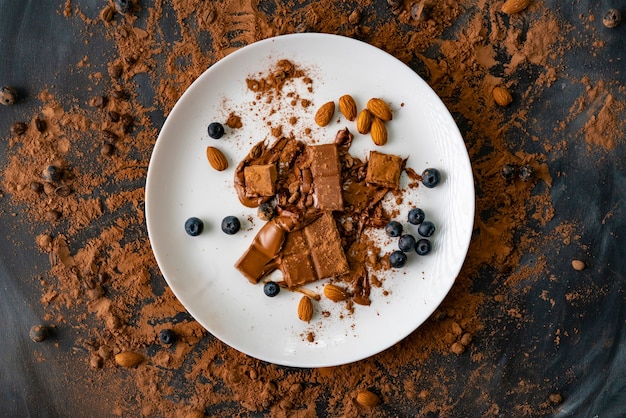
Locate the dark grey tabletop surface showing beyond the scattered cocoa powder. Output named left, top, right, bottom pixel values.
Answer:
left=0, top=0, right=626, bottom=417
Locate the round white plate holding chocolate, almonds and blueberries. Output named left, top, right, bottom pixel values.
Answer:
left=146, top=34, right=474, bottom=367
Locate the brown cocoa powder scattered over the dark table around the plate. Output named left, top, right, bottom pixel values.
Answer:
left=1, top=0, right=625, bottom=417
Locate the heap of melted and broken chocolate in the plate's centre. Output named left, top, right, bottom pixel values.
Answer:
left=235, top=129, right=405, bottom=305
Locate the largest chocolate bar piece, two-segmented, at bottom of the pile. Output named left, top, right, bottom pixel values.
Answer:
left=280, top=212, right=350, bottom=288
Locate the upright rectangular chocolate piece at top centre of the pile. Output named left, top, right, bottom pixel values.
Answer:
left=307, top=144, right=343, bottom=210
